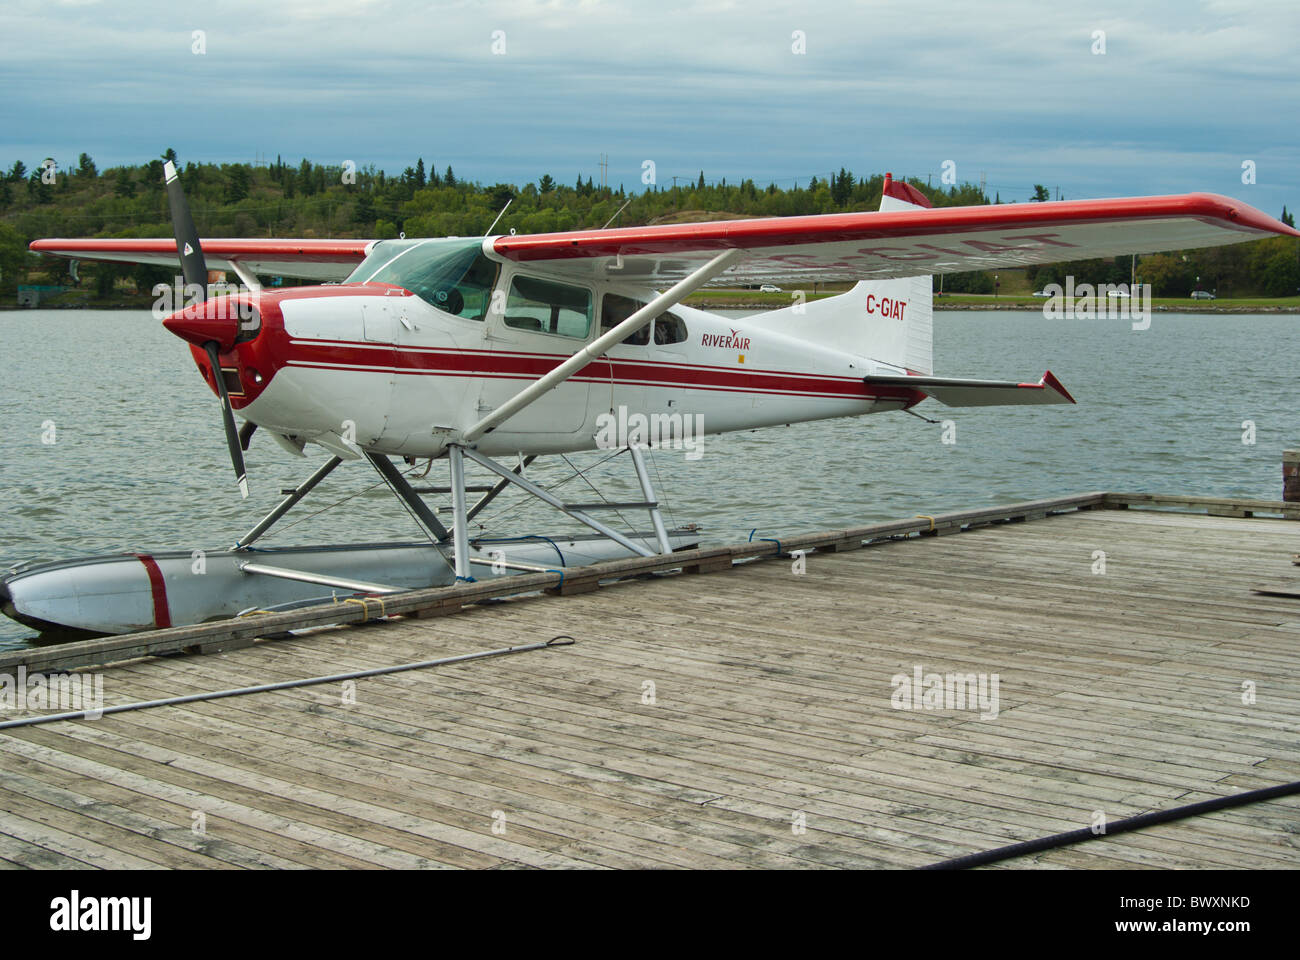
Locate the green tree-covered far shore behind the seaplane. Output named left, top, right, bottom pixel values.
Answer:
left=0, top=148, right=1300, bottom=302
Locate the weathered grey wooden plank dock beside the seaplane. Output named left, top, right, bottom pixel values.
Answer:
left=0, top=493, right=1300, bottom=869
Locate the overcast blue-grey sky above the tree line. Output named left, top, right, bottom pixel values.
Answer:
left=0, top=0, right=1300, bottom=216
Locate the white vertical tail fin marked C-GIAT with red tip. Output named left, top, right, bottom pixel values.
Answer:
left=749, top=173, right=935, bottom=375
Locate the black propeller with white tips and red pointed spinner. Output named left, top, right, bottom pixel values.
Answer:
left=163, top=160, right=256, bottom=498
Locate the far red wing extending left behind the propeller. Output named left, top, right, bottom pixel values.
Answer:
left=31, top=237, right=376, bottom=281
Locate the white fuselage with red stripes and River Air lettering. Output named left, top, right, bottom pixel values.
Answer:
left=178, top=244, right=928, bottom=457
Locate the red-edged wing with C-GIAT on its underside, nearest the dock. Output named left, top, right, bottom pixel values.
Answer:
left=491, top=194, right=1300, bottom=284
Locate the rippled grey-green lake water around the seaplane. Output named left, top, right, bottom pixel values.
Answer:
left=0, top=311, right=1300, bottom=649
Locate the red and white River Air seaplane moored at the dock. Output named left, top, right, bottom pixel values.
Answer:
left=0, top=163, right=1300, bottom=633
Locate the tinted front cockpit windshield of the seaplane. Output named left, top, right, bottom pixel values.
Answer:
left=343, top=238, right=497, bottom=320
